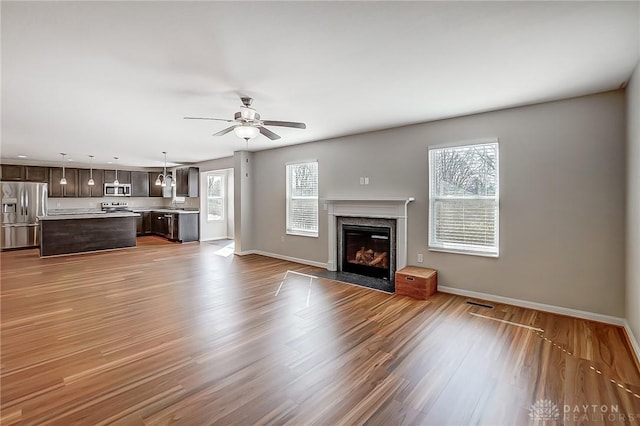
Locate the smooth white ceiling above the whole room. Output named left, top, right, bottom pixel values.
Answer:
left=1, top=1, right=640, bottom=167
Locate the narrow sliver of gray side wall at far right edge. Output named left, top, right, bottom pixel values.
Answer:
left=626, top=64, right=640, bottom=342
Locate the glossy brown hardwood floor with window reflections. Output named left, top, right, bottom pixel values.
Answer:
left=0, top=237, right=640, bottom=425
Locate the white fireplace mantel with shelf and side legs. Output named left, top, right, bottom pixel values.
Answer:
left=322, top=197, right=415, bottom=271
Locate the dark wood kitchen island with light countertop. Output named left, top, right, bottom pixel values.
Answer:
left=38, top=212, right=139, bottom=257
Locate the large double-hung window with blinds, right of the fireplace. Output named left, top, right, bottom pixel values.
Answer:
left=429, top=140, right=499, bottom=257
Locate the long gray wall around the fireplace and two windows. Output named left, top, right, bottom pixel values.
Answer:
left=249, top=91, right=625, bottom=316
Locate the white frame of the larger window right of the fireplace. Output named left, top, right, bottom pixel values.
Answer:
left=427, top=138, right=500, bottom=258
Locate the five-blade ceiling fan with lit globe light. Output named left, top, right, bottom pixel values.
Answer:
left=185, top=97, right=307, bottom=141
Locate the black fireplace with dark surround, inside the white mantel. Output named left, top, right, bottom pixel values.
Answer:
left=336, top=217, right=396, bottom=281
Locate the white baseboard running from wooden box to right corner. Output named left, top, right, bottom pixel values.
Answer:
left=438, top=285, right=627, bottom=327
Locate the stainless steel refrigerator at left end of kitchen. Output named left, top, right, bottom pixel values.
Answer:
left=0, top=182, right=47, bottom=250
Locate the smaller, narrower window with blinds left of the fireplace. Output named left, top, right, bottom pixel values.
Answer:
left=287, top=161, right=318, bottom=237
